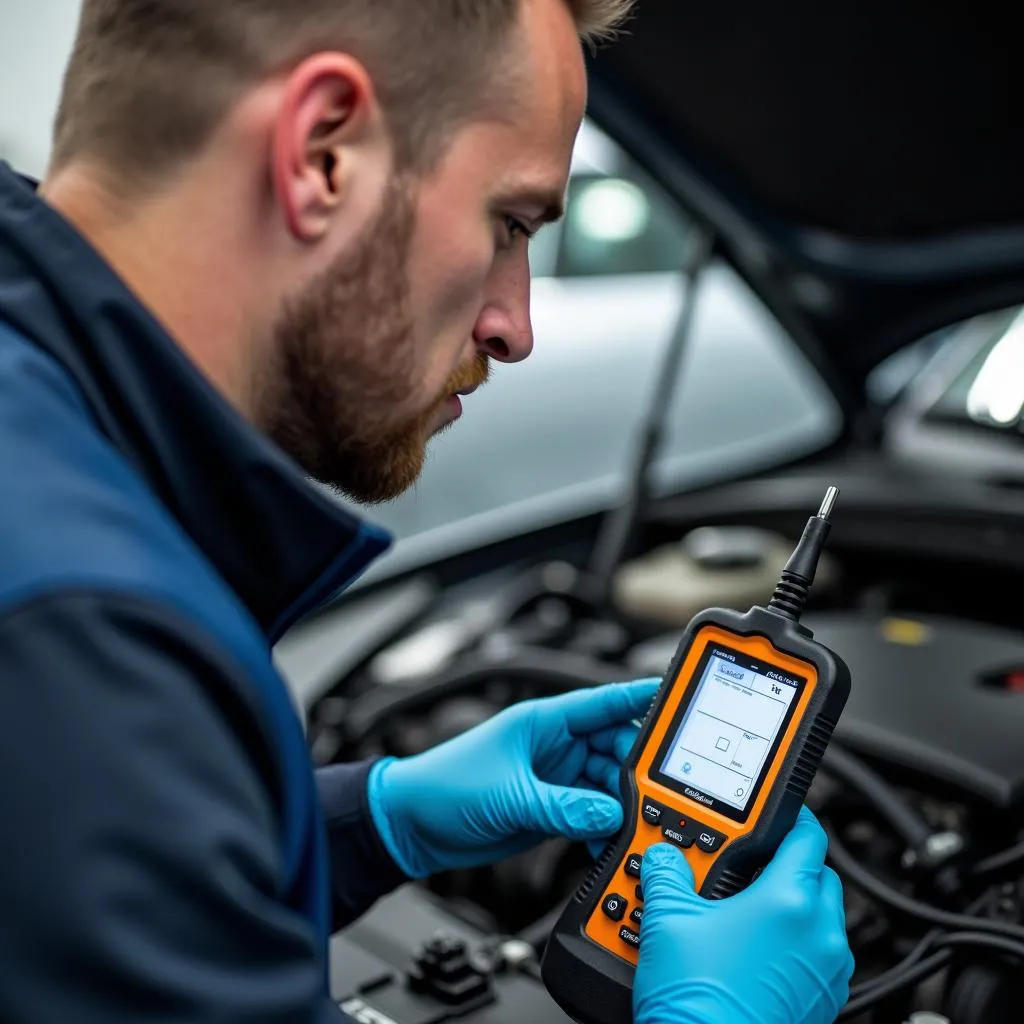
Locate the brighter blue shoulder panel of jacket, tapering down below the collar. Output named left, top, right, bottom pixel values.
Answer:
left=0, top=325, right=312, bottom=861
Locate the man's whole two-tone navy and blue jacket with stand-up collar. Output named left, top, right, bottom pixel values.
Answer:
left=0, top=165, right=406, bottom=1024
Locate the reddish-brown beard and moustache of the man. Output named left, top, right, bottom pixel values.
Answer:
left=257, top=179, right=488, bottom=504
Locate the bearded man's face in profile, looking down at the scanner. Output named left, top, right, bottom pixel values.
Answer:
left=265, top=0, right=586, bottom=502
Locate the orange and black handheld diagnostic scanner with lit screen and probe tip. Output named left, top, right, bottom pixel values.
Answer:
left=542, top=487, right=850, bottom=1024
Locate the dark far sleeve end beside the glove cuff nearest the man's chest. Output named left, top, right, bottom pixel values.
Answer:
left=316, top=762, right=410, bottom=929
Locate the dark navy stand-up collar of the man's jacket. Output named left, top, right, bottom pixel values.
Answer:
left=0, top=163, right=391, bottom=643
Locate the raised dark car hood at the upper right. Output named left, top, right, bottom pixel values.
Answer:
left=591, top=0, right=1024, bottom=409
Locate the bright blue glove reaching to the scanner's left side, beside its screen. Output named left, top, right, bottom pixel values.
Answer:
left=370, top=679, right=658, bottom=878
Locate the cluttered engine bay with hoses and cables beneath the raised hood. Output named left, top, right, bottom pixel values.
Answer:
left=308, top=471, right=1024, bottom=1024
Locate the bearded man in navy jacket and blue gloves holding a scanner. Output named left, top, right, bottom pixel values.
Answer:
left=0, top=0, right=852, bottom=1024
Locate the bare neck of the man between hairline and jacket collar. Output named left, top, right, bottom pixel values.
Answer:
left=40, top=161, right=266, bottom=418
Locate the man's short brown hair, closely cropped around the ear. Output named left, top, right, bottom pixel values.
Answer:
left=51, top=0, right=635, bottom=185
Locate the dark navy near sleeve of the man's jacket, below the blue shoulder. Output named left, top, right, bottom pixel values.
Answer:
left=0, top=593, right=347, bottom=1024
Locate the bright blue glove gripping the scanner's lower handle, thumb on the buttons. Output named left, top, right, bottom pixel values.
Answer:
left=633, top=808, right=853, bottom=1024
